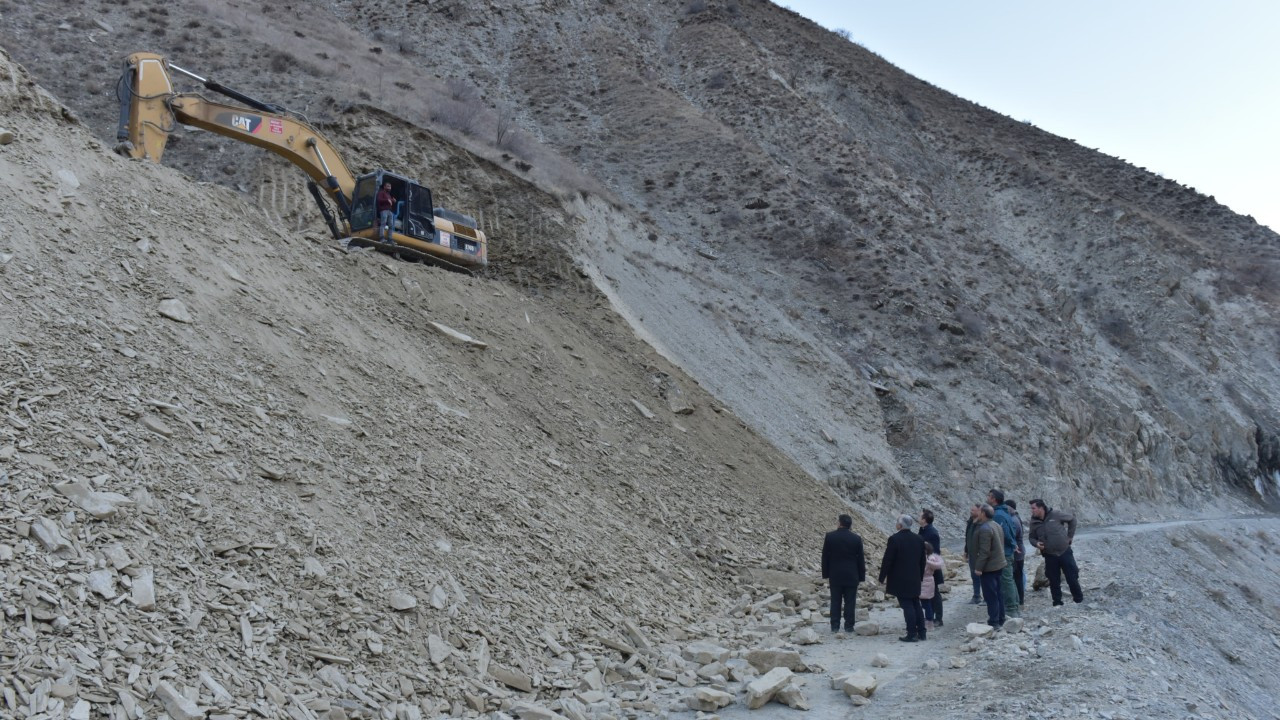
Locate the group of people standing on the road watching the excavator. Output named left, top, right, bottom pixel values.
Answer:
left=822, top=489, right=1084, bottom=642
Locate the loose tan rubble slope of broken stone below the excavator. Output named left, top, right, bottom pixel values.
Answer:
left=0, top=47, right=878, bottom=717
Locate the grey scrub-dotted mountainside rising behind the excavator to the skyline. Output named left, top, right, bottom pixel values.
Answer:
left=12, top=0, right=1280, bottom=514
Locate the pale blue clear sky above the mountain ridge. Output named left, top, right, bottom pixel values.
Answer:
left=778, top=0, right=1280, bottom=232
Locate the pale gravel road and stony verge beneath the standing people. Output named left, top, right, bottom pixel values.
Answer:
left=711, top=516, right=1280, bottom=720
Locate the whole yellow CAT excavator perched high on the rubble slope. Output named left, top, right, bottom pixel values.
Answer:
left=116, top=53, right=489, bottom=273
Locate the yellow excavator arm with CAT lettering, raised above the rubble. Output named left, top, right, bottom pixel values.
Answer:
left=116, top=53, right=356, bottom=215
